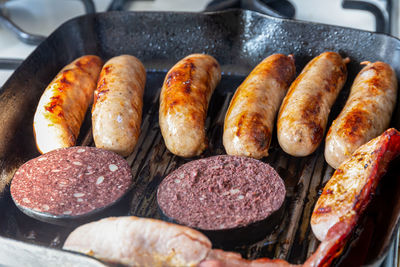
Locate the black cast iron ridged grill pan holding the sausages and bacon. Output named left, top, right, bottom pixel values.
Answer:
left=0, top=10, right=400, bottom=266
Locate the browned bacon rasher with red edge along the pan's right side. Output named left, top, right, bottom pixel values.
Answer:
left=304, top=128, right=400, bottom=266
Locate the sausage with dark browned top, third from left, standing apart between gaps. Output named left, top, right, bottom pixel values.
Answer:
left=159, top=54, right=221, bottom=157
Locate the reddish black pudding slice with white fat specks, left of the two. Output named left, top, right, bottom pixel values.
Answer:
left=11, top=147, right=132, bottom=216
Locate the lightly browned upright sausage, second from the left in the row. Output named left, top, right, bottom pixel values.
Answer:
left=92, top=55, right=146, bottom=156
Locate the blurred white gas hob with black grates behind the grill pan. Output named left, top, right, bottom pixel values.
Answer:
left=0, top=0, right=399, bottom=86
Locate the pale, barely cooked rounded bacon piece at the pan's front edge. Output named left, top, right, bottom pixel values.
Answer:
left=63, top=216, right=211, bottom=266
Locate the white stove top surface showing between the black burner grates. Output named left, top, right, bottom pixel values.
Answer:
left=0, top=0, right=392, bottom=86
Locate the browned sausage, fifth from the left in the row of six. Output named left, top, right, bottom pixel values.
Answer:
left=277, top=52, right=349, bottom=156
